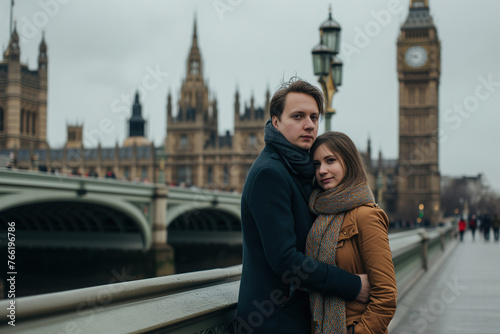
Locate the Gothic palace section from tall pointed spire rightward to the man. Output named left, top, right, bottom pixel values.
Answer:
left=165, top=22, right=269, bottom=190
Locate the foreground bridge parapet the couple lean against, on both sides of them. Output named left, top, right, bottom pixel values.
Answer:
left=0, top=226, right=456, bottom=334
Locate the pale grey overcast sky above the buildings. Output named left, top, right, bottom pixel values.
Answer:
left=0, top=0, right=500, bottom=192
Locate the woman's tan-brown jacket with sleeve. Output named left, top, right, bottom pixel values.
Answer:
left=336, top=204, right=397, bottom=334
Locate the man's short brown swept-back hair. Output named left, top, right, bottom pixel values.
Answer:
left=270, top=77, right=325, bottom=120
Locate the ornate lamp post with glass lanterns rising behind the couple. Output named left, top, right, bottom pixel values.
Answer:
left=312, top=5, right=343, bottom=131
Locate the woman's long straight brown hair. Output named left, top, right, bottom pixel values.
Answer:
left=311, top=131, right=368, bottom=193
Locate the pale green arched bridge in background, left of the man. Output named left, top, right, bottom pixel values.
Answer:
left=0, top=169, right=242, bottom=275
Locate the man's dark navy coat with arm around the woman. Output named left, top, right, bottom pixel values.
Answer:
left=238, top=145, right=361, bottom=334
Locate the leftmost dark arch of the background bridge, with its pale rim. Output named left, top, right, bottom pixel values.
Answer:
left=0, top=192, right=152, bottom=251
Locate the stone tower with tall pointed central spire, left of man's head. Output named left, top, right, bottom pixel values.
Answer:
left=165, top=20, right=219, bottom=187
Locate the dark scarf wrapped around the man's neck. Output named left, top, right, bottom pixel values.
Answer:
left=264, top=119, right=316, bottom=194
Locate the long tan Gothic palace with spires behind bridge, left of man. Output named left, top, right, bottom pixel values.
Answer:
left=0, top=22, right=270, bottom=191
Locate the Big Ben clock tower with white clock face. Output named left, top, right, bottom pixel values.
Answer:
left=397, top=0, right=441, bottom=225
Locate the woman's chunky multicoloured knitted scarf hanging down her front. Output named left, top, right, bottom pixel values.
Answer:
left=306, top=184, right=374, bottom=334
